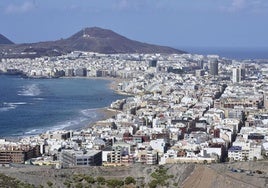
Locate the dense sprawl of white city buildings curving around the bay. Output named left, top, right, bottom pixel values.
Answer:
left=0, top=51, right=268, bottom=168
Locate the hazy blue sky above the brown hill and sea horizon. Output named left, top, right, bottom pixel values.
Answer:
left=0, top=0, right=268, bottom=47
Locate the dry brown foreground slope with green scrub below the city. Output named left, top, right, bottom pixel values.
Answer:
left=0, top=161, right=268, bottom=188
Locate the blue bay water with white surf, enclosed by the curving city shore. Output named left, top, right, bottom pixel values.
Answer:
left=0, top=75, right=125, bottom=137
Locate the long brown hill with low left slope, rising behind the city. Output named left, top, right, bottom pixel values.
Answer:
left=0, top=27, right=185, bottom=57
